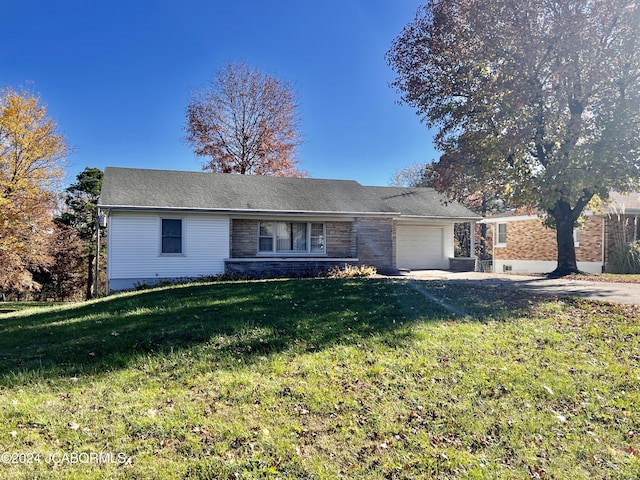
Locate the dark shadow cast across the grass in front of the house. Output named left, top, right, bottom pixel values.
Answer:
left=0, top=279, right=540, bottom=383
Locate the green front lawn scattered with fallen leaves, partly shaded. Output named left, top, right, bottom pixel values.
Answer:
left=0, top=279, right=640, bottom=479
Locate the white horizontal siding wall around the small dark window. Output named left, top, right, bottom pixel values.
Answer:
left=108, top=212, right=229, bottom=289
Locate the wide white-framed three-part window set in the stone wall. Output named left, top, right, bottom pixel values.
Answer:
left=258, top=222, right=325, bottom=253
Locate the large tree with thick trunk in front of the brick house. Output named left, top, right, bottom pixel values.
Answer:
left=387, top=0, right=640, bottom=274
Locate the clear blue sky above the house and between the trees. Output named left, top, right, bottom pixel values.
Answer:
left=0, top=0, right=438, bottom=185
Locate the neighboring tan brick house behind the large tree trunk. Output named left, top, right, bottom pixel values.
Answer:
left=483, top=192, right=640, bottom=273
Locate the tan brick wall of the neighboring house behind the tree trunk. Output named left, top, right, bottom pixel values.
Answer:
left=495, top=216, right=602, bottom=262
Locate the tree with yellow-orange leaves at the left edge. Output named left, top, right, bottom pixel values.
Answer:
left=0, top=89, right=68, bottom=292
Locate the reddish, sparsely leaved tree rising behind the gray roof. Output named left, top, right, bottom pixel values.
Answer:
left=186, top=63, right=307, bottom=177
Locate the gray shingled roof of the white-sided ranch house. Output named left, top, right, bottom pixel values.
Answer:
left=99, top=167, right=479, bottom=219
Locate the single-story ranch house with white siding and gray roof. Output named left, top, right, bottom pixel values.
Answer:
left=99, top=167, right=480, bottom=291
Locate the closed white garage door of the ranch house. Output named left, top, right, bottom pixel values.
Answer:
left=396, top=225, right=445, bottom=270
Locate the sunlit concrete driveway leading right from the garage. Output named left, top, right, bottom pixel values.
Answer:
left=403, top=270, right=640, bottom=305
